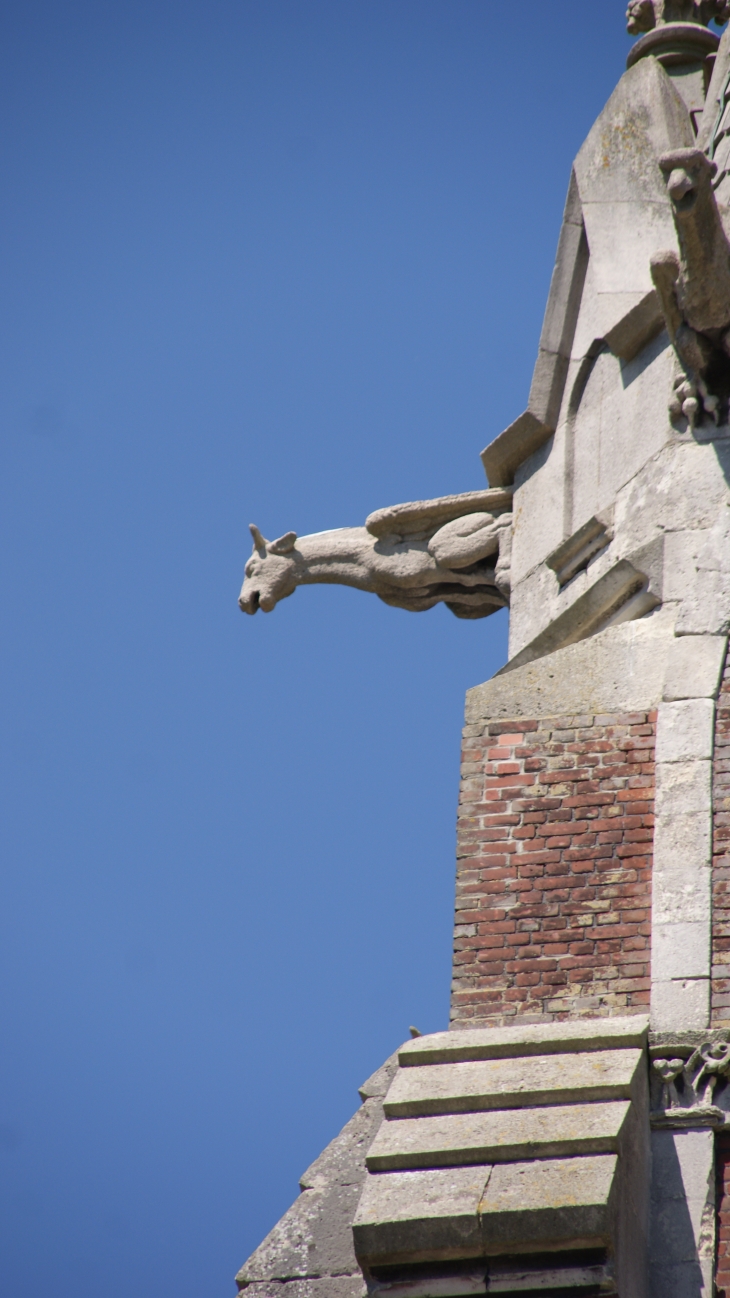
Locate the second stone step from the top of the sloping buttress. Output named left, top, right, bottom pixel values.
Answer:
left=383, top=1049, right=643, bottom=1118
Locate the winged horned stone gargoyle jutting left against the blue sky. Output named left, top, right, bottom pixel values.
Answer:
left=238, top=488, right=512, bottom=618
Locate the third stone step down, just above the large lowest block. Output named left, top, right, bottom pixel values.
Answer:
left=366, top=1099, right=631, bottom=1172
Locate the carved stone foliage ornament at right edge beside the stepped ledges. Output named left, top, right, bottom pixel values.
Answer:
left=649, top=1032, right=730, bottom=1127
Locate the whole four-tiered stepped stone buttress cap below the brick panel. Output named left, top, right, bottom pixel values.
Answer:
left=353, top=1016, right=648, bottom=1298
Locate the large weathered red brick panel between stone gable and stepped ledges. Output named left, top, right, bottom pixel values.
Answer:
left=452, top=713, right=656, bottom=1027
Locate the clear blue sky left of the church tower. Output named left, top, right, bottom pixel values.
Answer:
left=0, top=10, right=657, bottom=1298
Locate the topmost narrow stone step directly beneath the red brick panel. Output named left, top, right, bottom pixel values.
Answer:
left=397, top=1014, right=648, bottom=1068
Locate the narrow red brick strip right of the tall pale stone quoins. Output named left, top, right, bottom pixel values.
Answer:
left=712, top=646, right=730, bottom=1028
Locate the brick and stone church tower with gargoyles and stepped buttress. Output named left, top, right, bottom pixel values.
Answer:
left=236, top=0, right=730, bottom=1298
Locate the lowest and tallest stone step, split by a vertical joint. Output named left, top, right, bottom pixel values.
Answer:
left=352, top=1154, right=616, bottom=1267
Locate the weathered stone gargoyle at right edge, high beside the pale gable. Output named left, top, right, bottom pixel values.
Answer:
left=651, top=148, right=730, bottom=428
